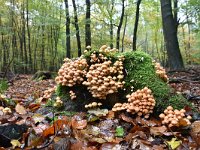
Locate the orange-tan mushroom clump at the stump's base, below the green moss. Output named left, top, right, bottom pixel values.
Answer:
left=112, top=87, right=156, bottom=118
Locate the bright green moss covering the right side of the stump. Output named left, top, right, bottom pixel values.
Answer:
left=124, top=51, right=170, bottom=99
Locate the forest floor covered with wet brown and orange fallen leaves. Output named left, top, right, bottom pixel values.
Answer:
left=0, top=66, right=200, bottom=150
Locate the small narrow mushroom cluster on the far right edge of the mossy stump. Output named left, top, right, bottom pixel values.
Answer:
left=153, top=61, right=169, bottom=82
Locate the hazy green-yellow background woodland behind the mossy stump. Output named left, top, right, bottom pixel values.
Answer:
left=0, top=0, right=200, bottom=73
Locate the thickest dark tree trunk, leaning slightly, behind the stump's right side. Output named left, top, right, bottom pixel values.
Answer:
left=160, top=0, right=184, bottom=70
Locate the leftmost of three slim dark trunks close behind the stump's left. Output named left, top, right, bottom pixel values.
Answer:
left=65, top=0, right=71, bottom=58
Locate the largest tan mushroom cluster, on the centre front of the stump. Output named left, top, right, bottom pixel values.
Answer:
left=83, top=56, right=125, bottom=99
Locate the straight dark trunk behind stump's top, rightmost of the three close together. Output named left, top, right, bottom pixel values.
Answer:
left=85, top=0, right=91, bottom=47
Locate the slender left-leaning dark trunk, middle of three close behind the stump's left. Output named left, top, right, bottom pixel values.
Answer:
left=72, top=0, right=81, bottom=57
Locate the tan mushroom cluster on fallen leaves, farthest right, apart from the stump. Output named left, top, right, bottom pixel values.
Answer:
left=159, top=106, right=192, bottom=128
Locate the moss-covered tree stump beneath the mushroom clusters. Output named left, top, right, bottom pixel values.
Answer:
left=56, top=51, right=190, bottom=113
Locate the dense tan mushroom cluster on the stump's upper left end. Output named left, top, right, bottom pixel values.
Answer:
left=55, top=58, right=88, bottom=87
